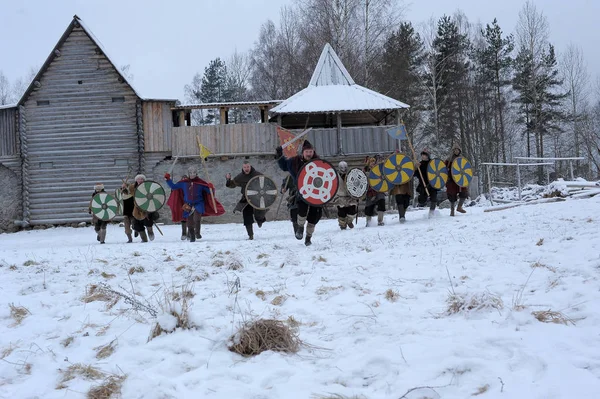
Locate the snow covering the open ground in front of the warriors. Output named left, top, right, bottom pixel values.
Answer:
left=0, top=197, right=600, bottom=399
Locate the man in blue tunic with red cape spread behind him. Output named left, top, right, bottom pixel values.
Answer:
left=165, top=166, right=214, bottom=242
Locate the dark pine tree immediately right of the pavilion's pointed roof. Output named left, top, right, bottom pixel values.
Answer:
left=374, top=22, right=424, bottom=132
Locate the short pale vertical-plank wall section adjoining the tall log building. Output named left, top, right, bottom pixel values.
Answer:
left=142, top=101, right=173, bottom=152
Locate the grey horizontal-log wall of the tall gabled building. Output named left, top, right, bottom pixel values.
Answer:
left=24, top=28, right=139, bottom=224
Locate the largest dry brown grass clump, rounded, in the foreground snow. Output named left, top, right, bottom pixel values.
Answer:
left=229, top=319, right=302, bottom=356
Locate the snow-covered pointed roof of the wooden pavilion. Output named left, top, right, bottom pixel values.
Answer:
left=271, top=43, right=410, bottom=114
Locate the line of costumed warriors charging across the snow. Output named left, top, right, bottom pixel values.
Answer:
left=89, top=140, right=469, bottom=246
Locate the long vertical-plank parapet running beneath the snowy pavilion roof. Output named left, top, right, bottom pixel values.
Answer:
left=172, top=123, right=396, bottom=157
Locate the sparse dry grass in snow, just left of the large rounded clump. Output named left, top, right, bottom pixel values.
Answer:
left=148, top=283, right=196, bottom=342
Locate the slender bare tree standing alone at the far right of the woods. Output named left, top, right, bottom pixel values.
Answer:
left=561, top=43, right=590, bottom=166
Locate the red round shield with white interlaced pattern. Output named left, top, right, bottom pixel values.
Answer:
left=298, top=159, right=339, bottom=206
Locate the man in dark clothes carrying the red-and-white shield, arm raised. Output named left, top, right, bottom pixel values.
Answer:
left=276, top=140, right=323, bottom=246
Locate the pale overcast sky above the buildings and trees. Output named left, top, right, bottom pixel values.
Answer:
left=0, top=0, right=600, bottom=100
